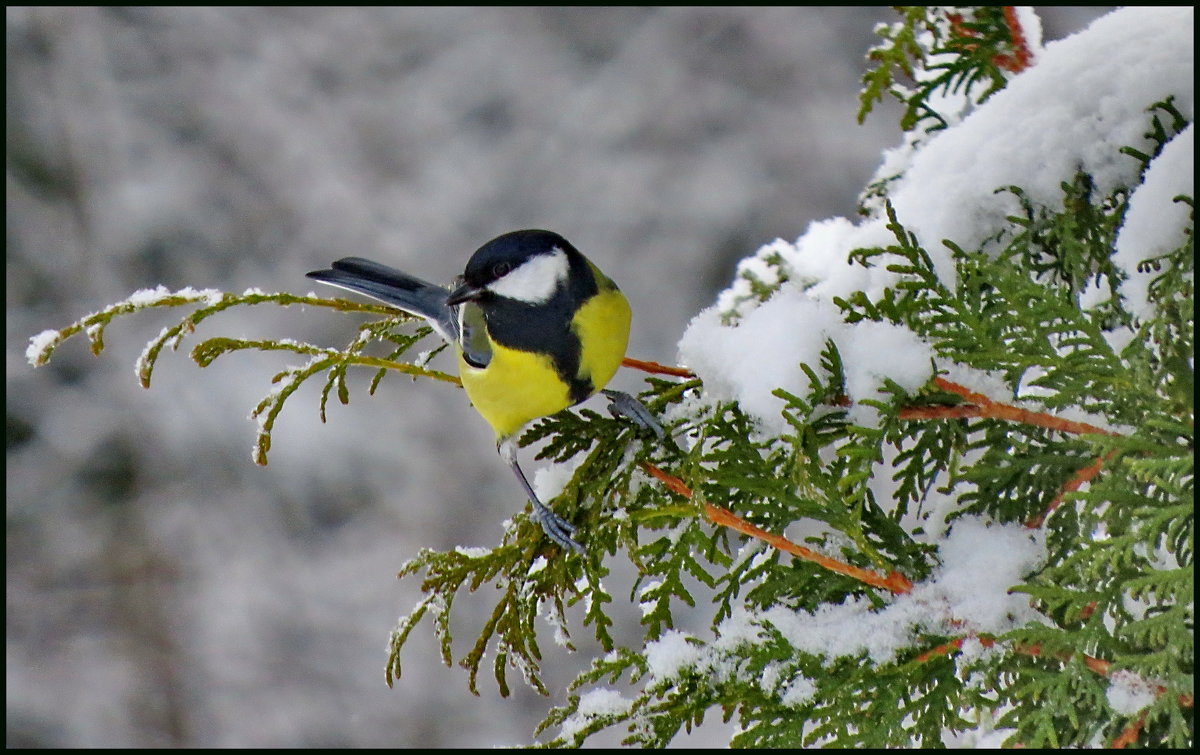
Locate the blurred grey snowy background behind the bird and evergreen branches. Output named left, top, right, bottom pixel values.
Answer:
left=6, top=7, right=1108, bottom=747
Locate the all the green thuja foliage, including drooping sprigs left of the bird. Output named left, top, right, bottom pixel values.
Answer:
left=30, top=7, right=1194, bottom=748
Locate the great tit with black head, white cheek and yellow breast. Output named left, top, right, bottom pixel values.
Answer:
left=307, top=230, right=661, bottom=552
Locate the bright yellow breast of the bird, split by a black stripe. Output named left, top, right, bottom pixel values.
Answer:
left=458, top=284, right=631, bottom=438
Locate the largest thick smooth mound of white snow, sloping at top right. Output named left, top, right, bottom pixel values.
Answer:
left=890, top=7, right=1194, bottom=272
